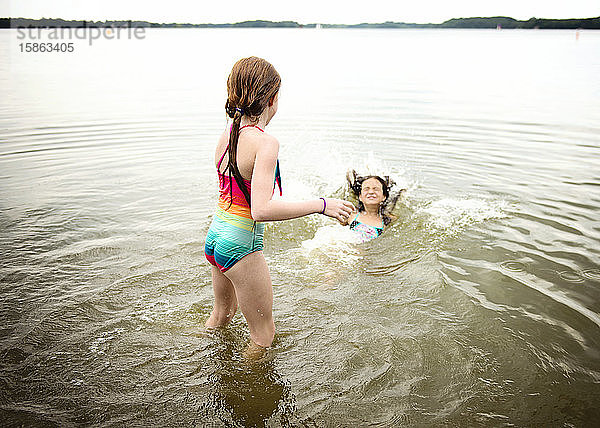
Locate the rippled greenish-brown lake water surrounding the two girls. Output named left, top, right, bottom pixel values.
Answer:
left=0, top=29, right=600, bottom=427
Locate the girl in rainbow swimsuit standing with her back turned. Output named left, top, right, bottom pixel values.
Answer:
left=205, top=57, right=354, bottom=353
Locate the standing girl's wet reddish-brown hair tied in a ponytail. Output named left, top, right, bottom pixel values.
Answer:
left=223, top=56, right=281, bottom=205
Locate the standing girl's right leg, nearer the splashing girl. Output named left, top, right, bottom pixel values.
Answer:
left=225, top=251, right=275, bottom=347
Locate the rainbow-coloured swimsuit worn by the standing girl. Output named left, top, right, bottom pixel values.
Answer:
left=204, top=127, right=281, bottom=272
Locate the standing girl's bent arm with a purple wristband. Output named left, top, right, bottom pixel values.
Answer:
left=250, top=135, right=354, bottom=221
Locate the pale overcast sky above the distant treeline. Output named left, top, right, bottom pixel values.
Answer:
left=0, top=0, right=600, bottom=24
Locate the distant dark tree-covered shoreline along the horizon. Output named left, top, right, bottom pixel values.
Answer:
left=0, top=16, right=600, bottom=30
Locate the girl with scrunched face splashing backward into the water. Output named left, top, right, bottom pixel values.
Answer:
left=340, top=170, right=406, bottom=242
